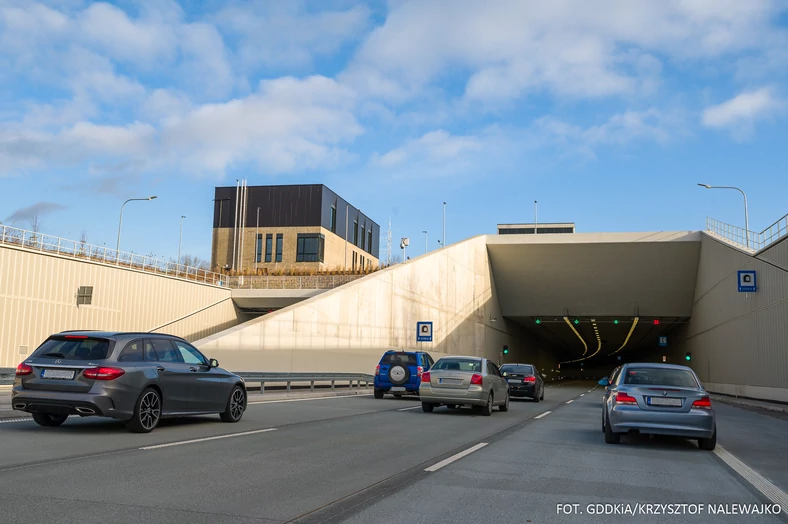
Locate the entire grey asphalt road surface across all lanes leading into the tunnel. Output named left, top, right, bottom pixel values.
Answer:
left=0, top=384, right=788, bottom=524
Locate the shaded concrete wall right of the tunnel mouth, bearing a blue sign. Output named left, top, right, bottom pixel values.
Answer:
left=671, top=234, right=788, bottom=402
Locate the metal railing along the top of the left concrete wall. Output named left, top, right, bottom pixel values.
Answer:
left=0, top=225, right=226, bottom=286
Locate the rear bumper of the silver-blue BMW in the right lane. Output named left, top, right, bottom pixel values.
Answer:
left=609, top=406, right=715, bottom=438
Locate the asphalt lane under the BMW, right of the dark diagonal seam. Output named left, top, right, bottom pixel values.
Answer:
left=338, top=384, right=788, bottom=524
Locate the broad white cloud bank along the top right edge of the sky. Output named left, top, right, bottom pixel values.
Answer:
left=344, top=0, right=778, bottom=102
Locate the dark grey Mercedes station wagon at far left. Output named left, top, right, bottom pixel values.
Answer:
left=11, top=331, right=246, bottom=433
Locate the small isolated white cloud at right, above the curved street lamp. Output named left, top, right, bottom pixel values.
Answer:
left=702, top=87, right=784, bottom=139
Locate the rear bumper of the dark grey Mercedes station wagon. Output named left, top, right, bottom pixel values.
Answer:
left=11, top=387, right=132, bottom=420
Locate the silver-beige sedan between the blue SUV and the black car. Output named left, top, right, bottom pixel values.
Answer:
left=419, top=356, right=509, bottom=416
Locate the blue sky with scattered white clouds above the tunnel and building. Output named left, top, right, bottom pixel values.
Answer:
left=0, top=0, right=788, bottom=259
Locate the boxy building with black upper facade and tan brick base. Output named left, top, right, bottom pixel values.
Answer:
left=211, top=183, right=380, bottom=273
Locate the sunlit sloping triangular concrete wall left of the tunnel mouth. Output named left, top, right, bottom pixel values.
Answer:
left=195, top=236, right=552, bottom=373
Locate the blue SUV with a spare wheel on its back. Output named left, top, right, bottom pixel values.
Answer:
left=375, top=350, right=435, bottom=398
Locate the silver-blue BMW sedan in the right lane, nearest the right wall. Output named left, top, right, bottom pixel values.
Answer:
left=600, top=364, right=717, bottom=451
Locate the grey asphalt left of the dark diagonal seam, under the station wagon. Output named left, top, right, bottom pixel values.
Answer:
left=0, top=384, right=587, bottom=523
